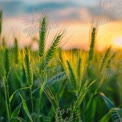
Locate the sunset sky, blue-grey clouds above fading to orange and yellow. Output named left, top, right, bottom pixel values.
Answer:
left=0, top=0, right=122, bottom=49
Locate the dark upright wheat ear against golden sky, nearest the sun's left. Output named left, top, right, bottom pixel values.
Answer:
left=89, top=28, right=96, bottom=61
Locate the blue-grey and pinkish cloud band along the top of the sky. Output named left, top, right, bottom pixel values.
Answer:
left=0, top=0, right=122, bottom=21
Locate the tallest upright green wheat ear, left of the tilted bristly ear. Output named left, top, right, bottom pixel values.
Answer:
left=39, top=17, right=47, bottom=57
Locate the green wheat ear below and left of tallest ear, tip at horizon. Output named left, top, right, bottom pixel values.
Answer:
left=24, top=48, right=33, bottom=87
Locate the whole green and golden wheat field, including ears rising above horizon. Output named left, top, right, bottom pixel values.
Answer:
left=0, top=11, right=122, bottom=122
